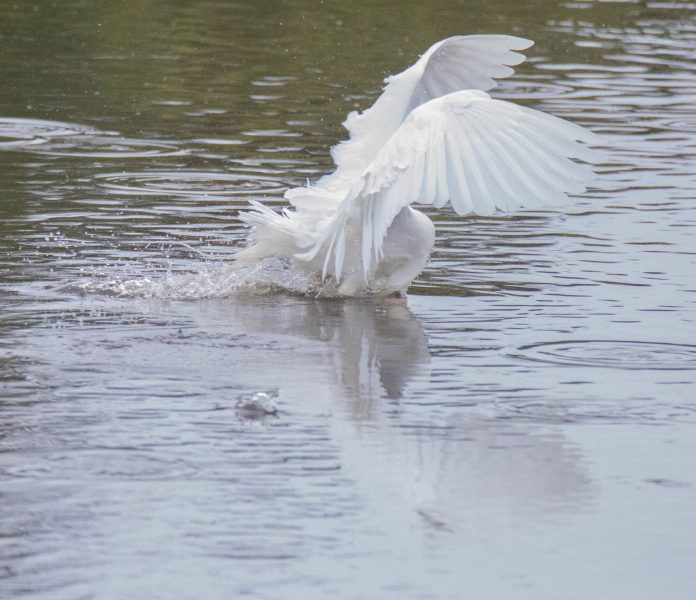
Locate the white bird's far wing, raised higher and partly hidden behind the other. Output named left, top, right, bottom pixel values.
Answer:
left=323, top=35, right=533, bottom=186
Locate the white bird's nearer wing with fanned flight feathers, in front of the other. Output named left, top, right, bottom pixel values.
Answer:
left=298, top=91, right=599, bottom=281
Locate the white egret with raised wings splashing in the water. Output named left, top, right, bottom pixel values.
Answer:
left=235, top=35, right=597, bottom=296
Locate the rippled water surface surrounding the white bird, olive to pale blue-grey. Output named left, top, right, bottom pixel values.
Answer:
left=0, top=0, right=696, bottom=600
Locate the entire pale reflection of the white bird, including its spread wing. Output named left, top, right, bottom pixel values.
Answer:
left=208, top=298, right=592, bottom=530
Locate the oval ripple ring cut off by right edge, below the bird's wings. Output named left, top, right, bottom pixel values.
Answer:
left=513, top=340, right=696, bottom=371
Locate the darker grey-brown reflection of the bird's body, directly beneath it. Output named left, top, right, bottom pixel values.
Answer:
left=215, top=298, right=430, bottom=401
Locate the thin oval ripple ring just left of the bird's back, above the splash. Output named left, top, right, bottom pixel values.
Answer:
left=96, top=169, right=285, bottom=197
